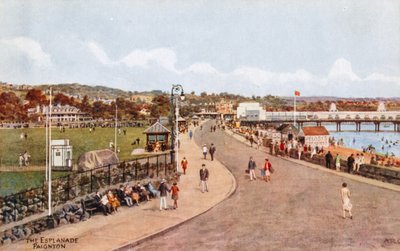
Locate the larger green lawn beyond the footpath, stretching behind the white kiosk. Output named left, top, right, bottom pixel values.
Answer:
left=0, top=127, right=146, bottom=167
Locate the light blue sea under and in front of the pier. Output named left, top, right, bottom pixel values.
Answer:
left=323, top=124, right=400, bottom=157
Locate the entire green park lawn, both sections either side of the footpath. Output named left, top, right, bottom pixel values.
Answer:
left=0, top=127, right=146, bottom=196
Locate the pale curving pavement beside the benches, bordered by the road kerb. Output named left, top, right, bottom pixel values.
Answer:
left=6, top=125, right=236, bottom=251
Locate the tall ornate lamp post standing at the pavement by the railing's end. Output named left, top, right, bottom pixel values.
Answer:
left=171, top=84, right=185, bottom=172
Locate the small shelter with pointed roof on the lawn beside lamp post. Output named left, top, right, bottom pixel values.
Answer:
left=143, top=121, right=171, bottom=152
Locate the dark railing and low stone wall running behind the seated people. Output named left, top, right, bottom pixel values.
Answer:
left=0, top=153, right=175, bottom=226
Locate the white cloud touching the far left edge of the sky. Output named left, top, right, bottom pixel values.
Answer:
left=0, top=37, right=52, bottom=68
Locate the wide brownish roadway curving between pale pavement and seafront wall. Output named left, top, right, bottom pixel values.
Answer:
left=135, top=120, right=400, bottom=250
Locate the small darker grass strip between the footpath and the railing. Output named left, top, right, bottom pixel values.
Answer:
left=0, top=172, right=68, bottom=196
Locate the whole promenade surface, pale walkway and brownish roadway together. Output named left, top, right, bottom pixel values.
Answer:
left=1, top=121, right=400, bottom=251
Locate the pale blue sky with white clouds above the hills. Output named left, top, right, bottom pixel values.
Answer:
left=0, top=0, right=400, bottom=97
